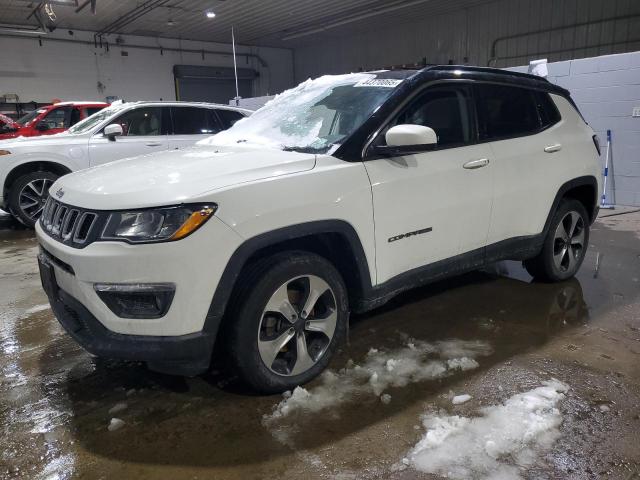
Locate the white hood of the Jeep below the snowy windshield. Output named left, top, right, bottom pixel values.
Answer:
left=50, top=146, right=315, bottom=210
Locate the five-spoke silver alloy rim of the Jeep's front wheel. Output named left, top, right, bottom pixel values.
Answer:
left=258, top=275, right=338, bottom=376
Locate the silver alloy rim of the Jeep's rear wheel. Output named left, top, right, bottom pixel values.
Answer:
left=553, top=211, right=585, bottom=272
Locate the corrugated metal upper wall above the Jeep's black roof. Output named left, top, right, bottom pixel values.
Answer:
left=295, top=0, right=640, bottom=81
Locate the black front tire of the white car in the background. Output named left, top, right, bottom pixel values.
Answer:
left=7, top=171, right=60, bottom=228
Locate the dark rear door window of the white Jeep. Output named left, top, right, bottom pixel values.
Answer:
left=477, top=85, right=541, bottom=140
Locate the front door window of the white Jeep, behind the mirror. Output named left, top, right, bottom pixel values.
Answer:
left=390, top=86, right=473, bottom=148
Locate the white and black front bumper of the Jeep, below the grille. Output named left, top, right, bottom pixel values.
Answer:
left=36, top=218, right=245, bottom=376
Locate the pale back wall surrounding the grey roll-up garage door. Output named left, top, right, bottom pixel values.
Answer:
left=0, top=30, right=293, bottom=103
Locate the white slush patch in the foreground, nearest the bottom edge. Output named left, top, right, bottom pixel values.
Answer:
left=403, top=380, right=569, bottom=480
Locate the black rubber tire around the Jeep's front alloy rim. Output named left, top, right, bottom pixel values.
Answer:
left=224, top=251, right=349, bottom=394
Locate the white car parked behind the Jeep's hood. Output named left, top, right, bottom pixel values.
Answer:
left=0, top=102, right=252, bottom=227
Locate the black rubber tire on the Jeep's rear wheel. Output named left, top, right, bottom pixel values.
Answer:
left=524, top=198, right=590, bottom=282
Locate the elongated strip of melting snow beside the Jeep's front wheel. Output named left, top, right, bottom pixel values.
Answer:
left=264, top=340, right=492, bottom=424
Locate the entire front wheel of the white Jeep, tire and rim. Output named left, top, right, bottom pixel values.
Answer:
left=226, top=252, right=348, bottom=393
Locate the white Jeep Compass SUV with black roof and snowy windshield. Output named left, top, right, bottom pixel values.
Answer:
left=36, top=66, right=601, bottom=392
